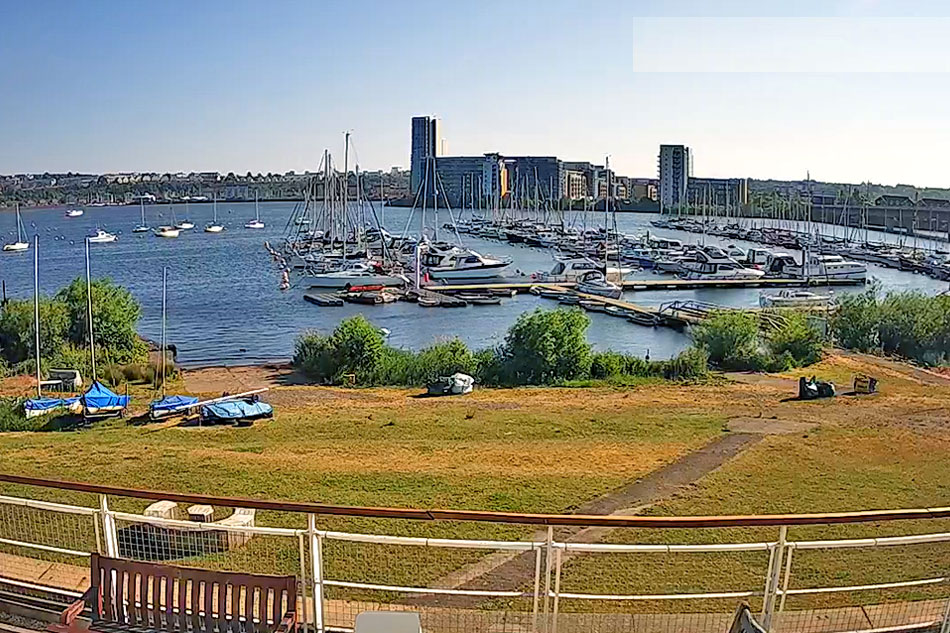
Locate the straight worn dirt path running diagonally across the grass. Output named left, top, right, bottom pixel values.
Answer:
left=413, top=433, right=763, bottom=608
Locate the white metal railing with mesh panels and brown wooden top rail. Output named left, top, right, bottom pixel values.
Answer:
left=0, top=476, right=950, bottom=633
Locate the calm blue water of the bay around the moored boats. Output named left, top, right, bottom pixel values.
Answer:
left=0, top=203, right=947, bottom=365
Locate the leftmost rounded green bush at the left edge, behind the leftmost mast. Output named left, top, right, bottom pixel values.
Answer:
left=0, top=298, right=69, bottom=364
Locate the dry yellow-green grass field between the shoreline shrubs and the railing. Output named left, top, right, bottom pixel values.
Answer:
left=0, top=356, right=950, bottom=610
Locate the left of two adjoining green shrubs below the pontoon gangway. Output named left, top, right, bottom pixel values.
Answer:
left=693, top=310, right=762, bottom=371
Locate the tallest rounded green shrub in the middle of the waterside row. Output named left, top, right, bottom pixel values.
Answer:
left=501, top=308, right=591, bottom=385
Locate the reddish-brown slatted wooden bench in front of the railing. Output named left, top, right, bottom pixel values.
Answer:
left=48, top=554, right=297, bottom=633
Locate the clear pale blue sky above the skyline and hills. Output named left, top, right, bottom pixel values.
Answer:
left=0, top=0, right=950, bottom=187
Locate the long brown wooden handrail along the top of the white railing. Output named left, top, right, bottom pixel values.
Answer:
left=0, top=473, right=950, bottom=528
